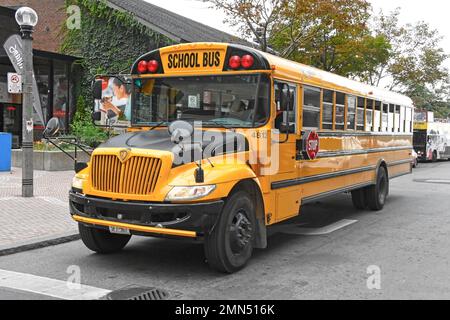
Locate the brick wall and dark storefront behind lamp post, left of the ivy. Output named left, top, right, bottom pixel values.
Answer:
left=0, top=0, right=76, bottom=148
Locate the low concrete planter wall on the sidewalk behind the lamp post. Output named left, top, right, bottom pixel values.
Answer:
left=12, top=150, right=90, bottom=171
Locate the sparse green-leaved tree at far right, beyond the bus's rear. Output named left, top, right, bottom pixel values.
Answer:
left=368, top=9, right=449, bottom=112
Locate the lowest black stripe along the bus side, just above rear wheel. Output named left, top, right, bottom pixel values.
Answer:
left=271, top=159, right=411, bottom=190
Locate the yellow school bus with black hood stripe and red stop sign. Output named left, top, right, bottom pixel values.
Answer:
left=70, top=43, right=414, bottom=273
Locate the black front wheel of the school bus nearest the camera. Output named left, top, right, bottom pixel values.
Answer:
left=204, top=191, right=256, bottom=273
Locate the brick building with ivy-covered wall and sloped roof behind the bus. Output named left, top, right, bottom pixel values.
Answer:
left=0, top=0, right=249, bottom=148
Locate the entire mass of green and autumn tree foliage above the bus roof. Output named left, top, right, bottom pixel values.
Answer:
left=203, top=0, right=450, bottom=117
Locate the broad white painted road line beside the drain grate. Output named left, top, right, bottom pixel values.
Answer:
left=0, top=269, right=111, bottom=300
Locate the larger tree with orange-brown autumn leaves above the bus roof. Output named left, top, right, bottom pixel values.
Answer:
left=204, top=0, right=389, bottom=76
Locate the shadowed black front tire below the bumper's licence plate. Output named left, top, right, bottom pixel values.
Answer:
left=78, top=223, right=131, bottom=254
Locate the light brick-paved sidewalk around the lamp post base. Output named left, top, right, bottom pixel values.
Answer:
left=0, top=168, right=78, bottom=256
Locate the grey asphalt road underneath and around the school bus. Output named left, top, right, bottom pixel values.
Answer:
left=0, top=162, right=450, bottom=300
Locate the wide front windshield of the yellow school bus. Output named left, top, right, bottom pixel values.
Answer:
left=132, top=74, right=270, bottom=127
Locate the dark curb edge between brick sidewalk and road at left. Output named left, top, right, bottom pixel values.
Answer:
left=0, top=232, right=80, bottom=257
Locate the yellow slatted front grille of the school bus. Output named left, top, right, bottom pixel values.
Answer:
left=92, top=155, right=162, bottom=195
